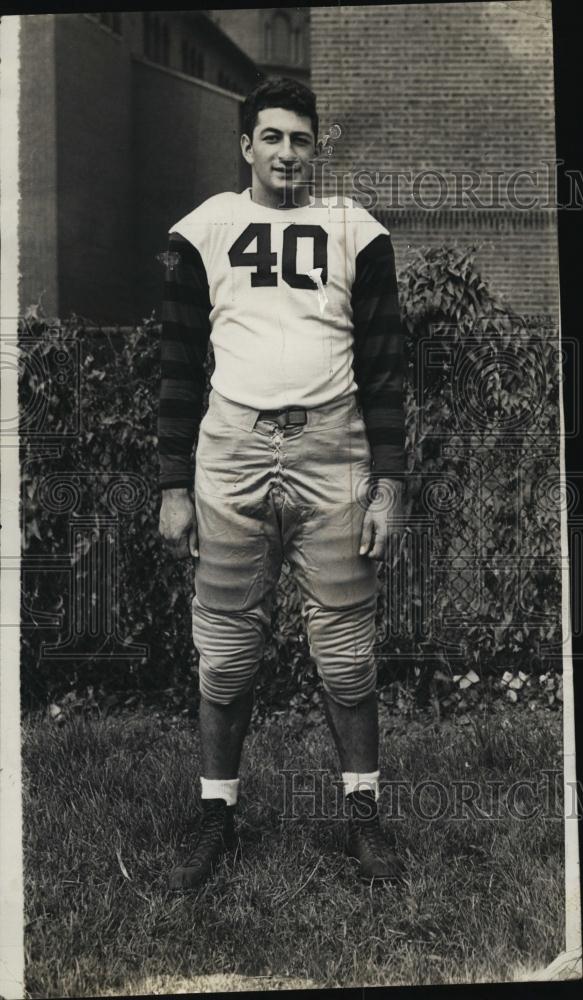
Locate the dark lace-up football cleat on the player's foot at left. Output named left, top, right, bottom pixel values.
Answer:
left=168, top=799, right=237, bottom=889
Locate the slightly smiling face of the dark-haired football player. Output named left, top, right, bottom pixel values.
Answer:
left=241, top=108, right=316, bottom=205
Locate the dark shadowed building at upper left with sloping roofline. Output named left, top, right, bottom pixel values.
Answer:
left=20, top=11, right=260, bottom=323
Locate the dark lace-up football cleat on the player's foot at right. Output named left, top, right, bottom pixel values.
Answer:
left=346, top=790, right=405, bottom=882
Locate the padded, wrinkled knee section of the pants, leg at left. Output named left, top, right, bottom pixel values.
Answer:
left=192, top=597, right=269, bottom=705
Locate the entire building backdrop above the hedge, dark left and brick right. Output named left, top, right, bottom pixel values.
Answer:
left=20, top=0, right=558, bottom=323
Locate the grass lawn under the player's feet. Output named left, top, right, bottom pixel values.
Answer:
left=23, top=709, right=564, bottom=997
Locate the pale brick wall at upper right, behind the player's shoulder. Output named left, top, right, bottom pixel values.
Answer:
left=311, top=0, right=558, bottom=313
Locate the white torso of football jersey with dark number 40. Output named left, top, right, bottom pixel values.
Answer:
left=170, top=189, right=388, bottom=410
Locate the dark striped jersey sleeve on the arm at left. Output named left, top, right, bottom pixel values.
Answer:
left=158, top=233, right=211, bottom=490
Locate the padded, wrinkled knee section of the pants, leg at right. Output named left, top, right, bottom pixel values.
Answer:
left=305, top=597, right=377, bottom=708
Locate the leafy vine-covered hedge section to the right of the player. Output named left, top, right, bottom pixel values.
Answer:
left=389, top=247, right=563, bottom=708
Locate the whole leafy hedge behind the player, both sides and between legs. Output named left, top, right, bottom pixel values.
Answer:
left=20, top=247, right=560, bottom=711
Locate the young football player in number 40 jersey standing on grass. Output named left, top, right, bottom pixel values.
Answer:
left=159, top=79, right=404, bottom=888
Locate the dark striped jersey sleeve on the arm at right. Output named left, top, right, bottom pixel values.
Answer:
left=352, top=234, right=405, bottom=477
